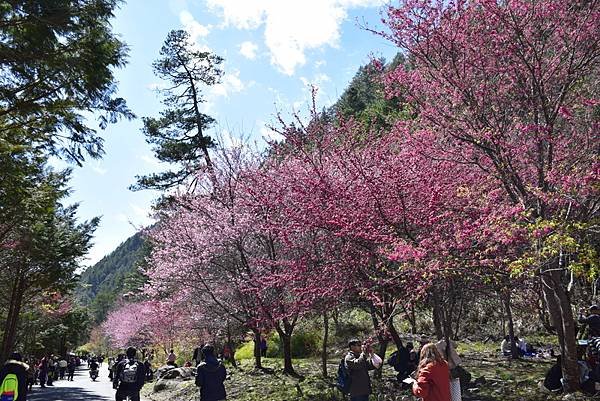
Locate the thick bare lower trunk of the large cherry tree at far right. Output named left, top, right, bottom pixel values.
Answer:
left=541, top=270, right=580, bottom=392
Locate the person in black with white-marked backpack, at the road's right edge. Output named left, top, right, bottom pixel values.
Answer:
left=113, top=347, right=146, bottom=401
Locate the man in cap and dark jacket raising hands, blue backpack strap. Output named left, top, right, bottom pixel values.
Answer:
left=344, top=339, right=381, bottom=401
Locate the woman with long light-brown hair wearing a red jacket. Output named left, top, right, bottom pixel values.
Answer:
left=413, top=343, right=451, bottom=401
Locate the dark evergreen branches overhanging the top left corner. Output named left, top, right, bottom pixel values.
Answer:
left=0, top=0, right=133, bottom=164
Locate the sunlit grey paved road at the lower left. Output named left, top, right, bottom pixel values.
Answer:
left=27, top=364, right=115, bottom=401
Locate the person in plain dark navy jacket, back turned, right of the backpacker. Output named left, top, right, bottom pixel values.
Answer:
left=196, top=345, right=227, bottom=401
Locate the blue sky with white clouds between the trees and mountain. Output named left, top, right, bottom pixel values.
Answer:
left=70, top=0, right=396, bottom=265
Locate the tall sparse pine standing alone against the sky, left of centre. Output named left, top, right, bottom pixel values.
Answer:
left=133, top=30, right=223, bottom=190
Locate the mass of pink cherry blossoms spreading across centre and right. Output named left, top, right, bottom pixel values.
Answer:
left=115, top=0, right=600, bottom=356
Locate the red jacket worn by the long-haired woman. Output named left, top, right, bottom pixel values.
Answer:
left=413, top=362, right=451, bottom=401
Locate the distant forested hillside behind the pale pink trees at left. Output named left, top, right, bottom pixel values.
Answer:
left=76, top=233, right=148, bottom=323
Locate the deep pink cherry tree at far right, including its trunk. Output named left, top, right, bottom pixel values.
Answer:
left=382, top=0, right=600, bottom=390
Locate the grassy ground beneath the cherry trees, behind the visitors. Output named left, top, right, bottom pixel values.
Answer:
left=145, top=342, right=580, bottom=401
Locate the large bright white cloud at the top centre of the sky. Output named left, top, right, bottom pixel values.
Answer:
left=207, top=0, right=387, bottom=75
